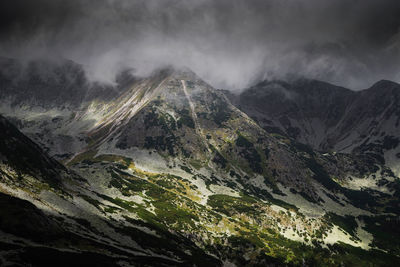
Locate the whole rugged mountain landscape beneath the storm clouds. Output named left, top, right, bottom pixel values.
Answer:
left=0, top=59, right=400, bottom=266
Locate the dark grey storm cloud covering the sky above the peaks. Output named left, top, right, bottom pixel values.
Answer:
left=0, top=0, right=400, bottom=89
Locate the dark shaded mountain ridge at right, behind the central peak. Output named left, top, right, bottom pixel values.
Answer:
left=228, top=80, right=400, bottom=176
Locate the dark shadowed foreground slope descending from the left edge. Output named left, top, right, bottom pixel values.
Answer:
left=0, top=117, right=222, bottom=266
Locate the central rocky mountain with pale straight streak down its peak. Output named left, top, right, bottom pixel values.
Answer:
left=0, top=59, right=400, bottom=266
